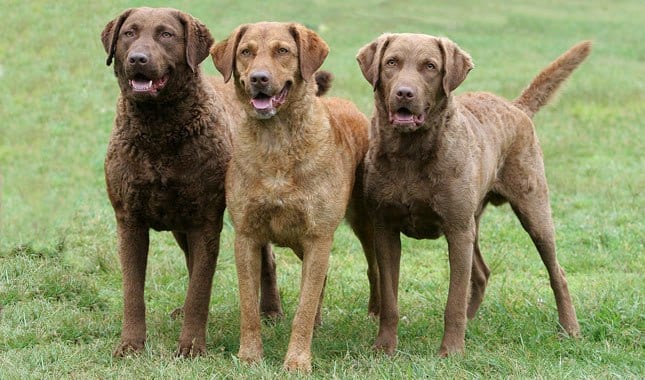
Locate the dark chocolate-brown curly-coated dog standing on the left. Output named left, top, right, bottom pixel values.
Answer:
left=101, top=8, right=282, bottom=356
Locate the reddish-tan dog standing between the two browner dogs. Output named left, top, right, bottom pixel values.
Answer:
left=211, top=23, right=378, bottom=371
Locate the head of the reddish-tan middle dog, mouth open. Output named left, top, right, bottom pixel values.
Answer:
left=211, top=22, right=329, bottom=119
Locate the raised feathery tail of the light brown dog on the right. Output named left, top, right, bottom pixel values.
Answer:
left=514, top=41, right=591, bottom=117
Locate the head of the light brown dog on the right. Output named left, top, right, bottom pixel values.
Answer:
left=356, top=33, right=473, bottom=132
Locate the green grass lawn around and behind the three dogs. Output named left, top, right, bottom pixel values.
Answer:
left=0, top=0, right=645, bottom=379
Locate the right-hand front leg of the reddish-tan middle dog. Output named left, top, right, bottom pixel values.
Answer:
left=284, top=235, right=333, bottom=373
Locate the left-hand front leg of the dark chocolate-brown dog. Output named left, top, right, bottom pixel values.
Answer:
left=113, top=219, right=149, bottom=356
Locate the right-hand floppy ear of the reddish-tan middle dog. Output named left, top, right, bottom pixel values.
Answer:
left=289, top=24, right=329, bottom=82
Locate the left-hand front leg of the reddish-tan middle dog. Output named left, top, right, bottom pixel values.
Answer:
left=235, top=232, right=262, bottom=363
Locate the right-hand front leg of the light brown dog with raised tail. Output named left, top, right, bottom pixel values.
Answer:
left=439, top=221, right=475, bottom=357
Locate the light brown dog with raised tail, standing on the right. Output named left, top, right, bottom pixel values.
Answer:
left=357, top=34, right=591, bottom=356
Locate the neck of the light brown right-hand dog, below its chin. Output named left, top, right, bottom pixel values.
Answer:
left=371, top=94, right=455, bottom=161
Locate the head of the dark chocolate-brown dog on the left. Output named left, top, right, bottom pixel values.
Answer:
left=101, top=8, right=213, bottom=100
